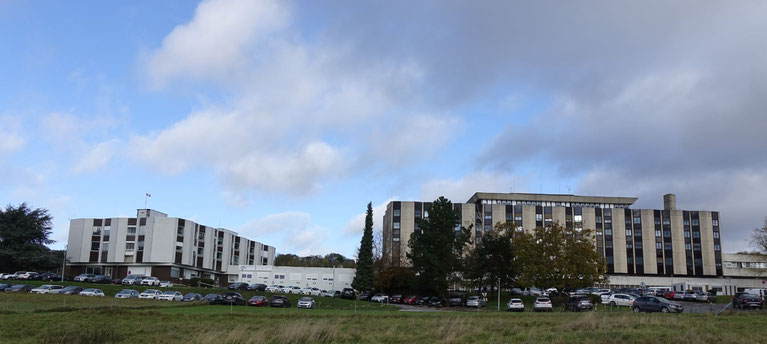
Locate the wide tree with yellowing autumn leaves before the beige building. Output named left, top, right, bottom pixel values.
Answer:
left=513, top=223, right=606, bottom=289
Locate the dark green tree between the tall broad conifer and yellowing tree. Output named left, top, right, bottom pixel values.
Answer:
left=463, top=222, right=516, bottom=288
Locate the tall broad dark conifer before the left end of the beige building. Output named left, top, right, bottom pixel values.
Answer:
left=407, top=197, right=471, bottom=294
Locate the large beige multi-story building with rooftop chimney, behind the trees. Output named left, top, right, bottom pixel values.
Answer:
left=383, top=192, right=764, bottom=294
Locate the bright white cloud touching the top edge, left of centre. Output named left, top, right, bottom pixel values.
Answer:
left=147, top=0, right=289, bottom=86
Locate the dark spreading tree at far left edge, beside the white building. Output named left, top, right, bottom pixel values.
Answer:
left=0, top=203, right=60, bottom=271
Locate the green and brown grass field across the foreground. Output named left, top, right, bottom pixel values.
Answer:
left=0, top=293, right=767, bottom=344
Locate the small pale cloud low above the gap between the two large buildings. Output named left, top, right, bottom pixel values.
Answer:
left=238, top=211, right=330, bottom=256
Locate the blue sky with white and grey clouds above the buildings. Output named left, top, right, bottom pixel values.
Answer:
left=0, top=0, right=767, bottom=256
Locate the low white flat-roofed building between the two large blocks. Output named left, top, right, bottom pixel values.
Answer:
left=236, top=265, right=356, bottom=290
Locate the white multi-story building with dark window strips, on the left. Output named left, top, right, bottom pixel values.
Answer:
left=67, top=209, right=275, bottom=283
